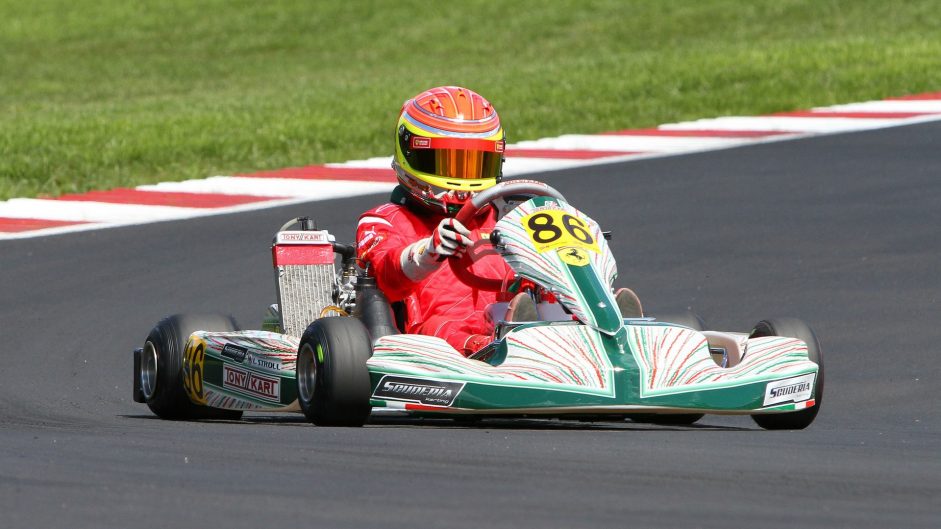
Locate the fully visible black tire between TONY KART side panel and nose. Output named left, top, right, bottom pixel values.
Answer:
left=297, top=317, right=372, bottom=426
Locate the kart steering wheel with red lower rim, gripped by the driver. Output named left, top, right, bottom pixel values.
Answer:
left=448, top=180, right=565, bottom=292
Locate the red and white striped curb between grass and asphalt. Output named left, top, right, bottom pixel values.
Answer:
left=0, top=92, right=941, bottom=239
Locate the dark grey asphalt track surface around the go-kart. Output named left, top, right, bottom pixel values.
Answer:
left=0, top=122, right=941, bottom=528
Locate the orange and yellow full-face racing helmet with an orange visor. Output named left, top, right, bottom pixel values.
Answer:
left=392, top=86, right=506, bottom=215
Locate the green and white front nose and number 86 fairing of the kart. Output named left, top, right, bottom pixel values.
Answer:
left=367, top=197, right=818, bottom=415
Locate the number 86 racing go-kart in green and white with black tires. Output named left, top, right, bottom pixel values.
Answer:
left=134, top=180, right=823, bottom=429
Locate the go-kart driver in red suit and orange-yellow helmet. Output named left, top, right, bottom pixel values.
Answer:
left=356, top=86, right=536, bottom=355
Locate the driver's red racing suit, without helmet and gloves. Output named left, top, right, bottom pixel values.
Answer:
left=356, top=203, right=512, bottom=355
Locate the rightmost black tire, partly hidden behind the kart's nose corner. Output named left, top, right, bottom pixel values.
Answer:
left=749, top=318, right=823, bottom=430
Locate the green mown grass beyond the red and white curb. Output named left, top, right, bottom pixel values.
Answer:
left=0, top=0, right=941, bottom=199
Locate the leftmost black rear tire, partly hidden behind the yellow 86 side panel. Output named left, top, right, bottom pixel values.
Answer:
left=137, top=314, right=242, bottom=420
